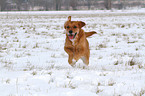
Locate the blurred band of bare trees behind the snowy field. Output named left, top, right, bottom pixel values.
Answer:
left=0, top=0, right=145, bottom=11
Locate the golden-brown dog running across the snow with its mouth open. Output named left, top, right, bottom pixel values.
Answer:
left=64, top=16, right=96, bottom=66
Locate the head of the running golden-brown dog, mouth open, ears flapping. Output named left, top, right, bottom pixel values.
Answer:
left=64, top=16, right=86, bottom=40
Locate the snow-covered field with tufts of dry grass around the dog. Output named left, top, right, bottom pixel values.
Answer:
left=0, top=11, right=145, bottom=96
